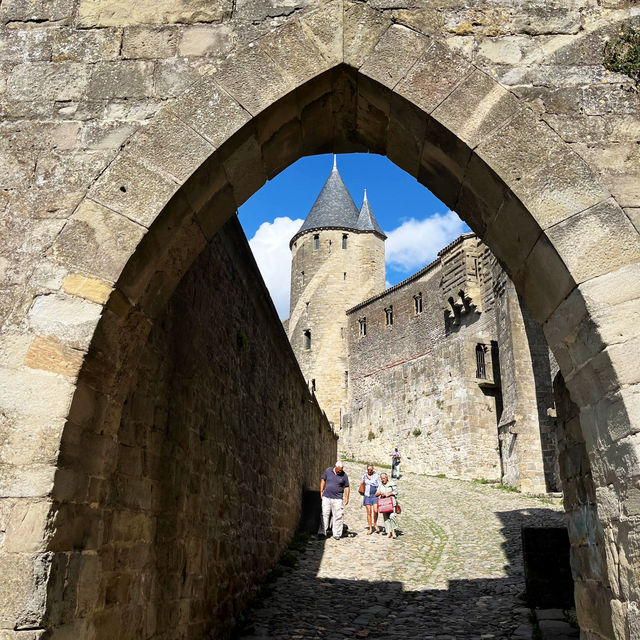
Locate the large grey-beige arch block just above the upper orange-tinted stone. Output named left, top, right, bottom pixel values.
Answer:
left=53, top=198, right=146, bottom=282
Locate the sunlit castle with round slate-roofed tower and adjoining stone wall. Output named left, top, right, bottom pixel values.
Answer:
left=287, top=161, right=559, bottom=492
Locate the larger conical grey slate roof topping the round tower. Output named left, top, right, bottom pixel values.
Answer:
left=294, top=161, right=358, bottom=242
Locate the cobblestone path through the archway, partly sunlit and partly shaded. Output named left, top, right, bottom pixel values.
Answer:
left=239, top=463, right=563, bottom=640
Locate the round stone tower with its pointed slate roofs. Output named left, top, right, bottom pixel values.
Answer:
left=289, top=157, right=386, bottom=429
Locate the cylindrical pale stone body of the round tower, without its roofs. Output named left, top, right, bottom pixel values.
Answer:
left=289, top=229, right=384, bottom=427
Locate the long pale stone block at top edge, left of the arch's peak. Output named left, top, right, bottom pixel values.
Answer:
left=77, top=0, right=232, bottom=28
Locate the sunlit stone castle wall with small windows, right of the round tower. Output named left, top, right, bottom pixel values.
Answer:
left=339, top=240, right=500, bottom=479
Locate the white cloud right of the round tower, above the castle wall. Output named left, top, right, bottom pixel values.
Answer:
left=385, top=211, right=467, bottom=271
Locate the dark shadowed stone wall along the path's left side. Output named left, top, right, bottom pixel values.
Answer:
left=42, top=219, right=336, bottom=640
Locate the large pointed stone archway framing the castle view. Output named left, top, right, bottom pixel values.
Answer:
left=0, top=4, right=640, bottom=637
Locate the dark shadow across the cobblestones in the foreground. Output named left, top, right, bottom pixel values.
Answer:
left=233, top=509, right=568, bottom=640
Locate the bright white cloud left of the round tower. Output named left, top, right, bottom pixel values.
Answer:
left=249, top=217, right=303, bottom=319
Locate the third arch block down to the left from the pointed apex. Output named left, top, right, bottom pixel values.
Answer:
left=215, top=41, right=296, bottom=116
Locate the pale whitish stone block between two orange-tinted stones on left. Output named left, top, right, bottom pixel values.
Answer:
left=29, top=294, right=102, bottom=350
